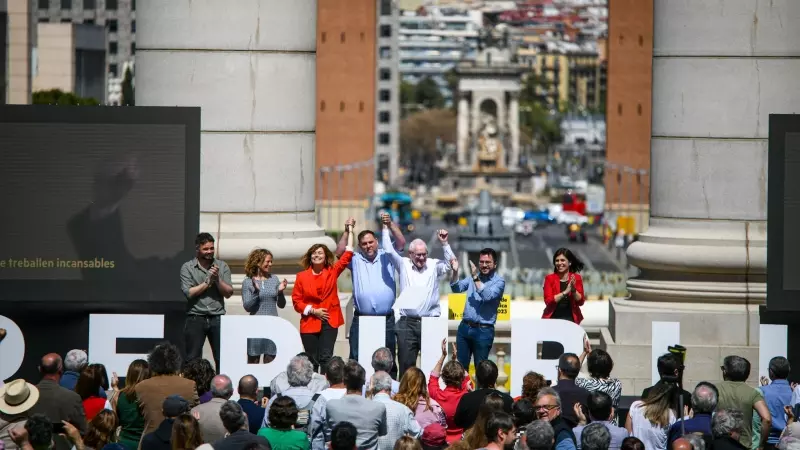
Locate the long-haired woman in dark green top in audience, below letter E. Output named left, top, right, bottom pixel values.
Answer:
left=114, top=359, right=150, bottom=450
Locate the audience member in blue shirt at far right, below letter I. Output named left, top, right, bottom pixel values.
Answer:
left=752, top=356, right=794, bottom=447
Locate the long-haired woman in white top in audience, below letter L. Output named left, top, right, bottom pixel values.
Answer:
left=625, top=383, right=689, bottom=450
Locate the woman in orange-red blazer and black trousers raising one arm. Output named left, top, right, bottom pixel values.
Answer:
left=292, top=227, right=353, bottom=374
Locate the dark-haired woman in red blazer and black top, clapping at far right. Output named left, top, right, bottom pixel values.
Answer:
left=542, top=248, right=586, bottom=325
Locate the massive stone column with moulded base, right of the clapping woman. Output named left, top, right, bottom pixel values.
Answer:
left=606, top=0, right=800, bottom=395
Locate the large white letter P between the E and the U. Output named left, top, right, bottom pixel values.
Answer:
left=220, top=316, right=304, bottom=396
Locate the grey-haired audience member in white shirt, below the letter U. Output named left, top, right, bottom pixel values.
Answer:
left=370, top=372, right=422, bottom=450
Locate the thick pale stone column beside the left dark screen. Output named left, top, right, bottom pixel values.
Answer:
left=136, top=0, right=334, bottom=281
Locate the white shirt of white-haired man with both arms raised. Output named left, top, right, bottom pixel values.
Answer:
left=381, top=231, right=456, bottom=317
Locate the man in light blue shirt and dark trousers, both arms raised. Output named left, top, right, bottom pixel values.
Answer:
left=336, top=213, right=406, bottom=372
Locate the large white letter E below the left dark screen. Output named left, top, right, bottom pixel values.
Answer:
left=89, top=314, right=164, bottom=376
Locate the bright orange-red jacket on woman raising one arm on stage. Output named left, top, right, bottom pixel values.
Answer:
left=292, top=250, right=353, bottom=333
